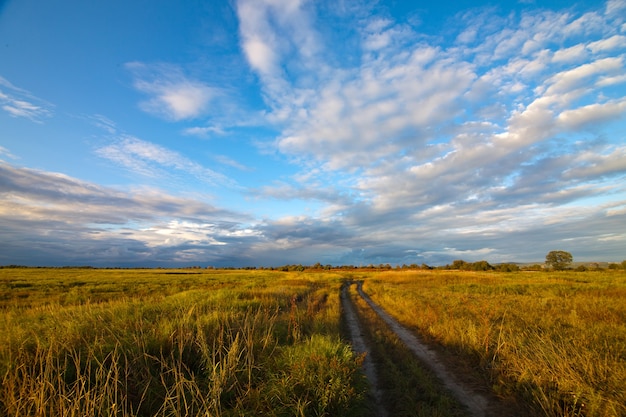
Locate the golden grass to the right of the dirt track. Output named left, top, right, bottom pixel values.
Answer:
left=364, top=271, right=626, bottom=416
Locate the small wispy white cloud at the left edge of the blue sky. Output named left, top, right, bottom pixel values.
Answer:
left=0, top=76, right=53, bottom=123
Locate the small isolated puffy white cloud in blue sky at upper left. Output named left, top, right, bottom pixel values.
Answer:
left=126, top=62, right=220, bottom=121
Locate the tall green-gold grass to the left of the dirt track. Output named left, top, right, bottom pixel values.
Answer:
left=0, top=268, right=367, bottom=416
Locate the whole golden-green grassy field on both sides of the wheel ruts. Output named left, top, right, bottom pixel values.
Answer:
left=0, top=268, right=626, bottom=416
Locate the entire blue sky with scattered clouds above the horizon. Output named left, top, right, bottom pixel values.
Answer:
left=0, top=0, right=626, bottom=267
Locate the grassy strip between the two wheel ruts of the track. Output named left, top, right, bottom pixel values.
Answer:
left=349, top=285, right=466, bottom=417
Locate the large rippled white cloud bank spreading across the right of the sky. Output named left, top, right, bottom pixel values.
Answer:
left=230, top=1, right=626, bottom=259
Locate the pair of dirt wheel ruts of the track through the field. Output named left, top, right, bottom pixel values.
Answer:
left=341, top=281, right=490, bottom=417
